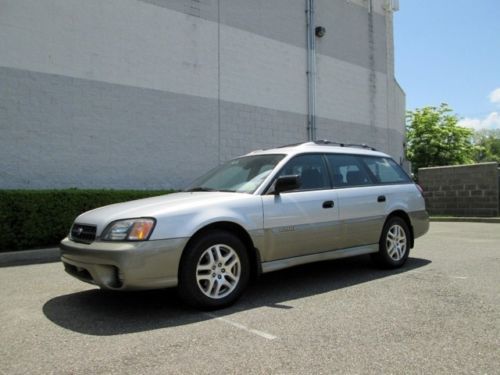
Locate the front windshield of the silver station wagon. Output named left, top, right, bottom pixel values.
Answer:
left=185, top=154, right=285, bottom=194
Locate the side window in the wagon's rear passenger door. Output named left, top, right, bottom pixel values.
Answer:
left=326, top=154, right=373, bottom=187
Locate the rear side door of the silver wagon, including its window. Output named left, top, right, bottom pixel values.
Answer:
left=326, top=154, right=386, bottom=248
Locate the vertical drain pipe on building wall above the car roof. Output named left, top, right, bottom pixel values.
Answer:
left=306, top=0, right=316, bottom=141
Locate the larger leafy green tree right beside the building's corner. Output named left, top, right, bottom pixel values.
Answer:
left=406, top=103, right=475, bottom=174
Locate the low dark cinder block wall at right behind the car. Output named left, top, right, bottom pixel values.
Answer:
left=418, top=163, right=500, bottom=217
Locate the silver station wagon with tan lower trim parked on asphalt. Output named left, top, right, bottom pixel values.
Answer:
left=60, top=141, right=429, bottom=308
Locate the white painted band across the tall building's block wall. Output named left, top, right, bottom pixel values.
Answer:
left=0, top=0, right=394, bottom=126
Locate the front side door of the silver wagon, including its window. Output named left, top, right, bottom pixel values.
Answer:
left=261, top=154, right=340, bottom=261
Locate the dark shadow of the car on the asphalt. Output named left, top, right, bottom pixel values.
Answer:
left=43, top=256, right=431, bottom=336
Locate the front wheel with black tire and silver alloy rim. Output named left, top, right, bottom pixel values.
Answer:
left=178, top=231, right=250, bottom=309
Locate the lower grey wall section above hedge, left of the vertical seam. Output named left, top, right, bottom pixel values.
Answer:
left=0, top=68, right=219, bottom=189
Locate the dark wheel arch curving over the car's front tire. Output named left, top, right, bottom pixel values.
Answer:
left=178, top=221, right=262, bottom=280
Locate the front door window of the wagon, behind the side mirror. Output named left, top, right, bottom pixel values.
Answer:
left=278, top=154, right=330, bottom=190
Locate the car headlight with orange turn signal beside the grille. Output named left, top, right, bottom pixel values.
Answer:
left=101, top=218, right=156, bottom=241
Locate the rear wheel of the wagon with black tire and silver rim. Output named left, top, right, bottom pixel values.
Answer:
left=372, top=216, right=411, bottom=268
